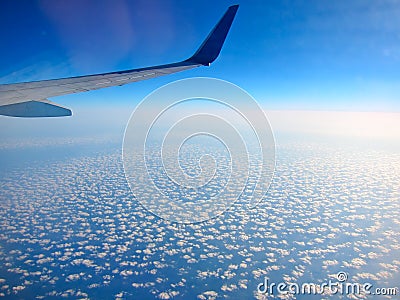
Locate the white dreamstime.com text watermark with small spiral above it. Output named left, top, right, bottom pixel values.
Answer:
left=257, top=271, right=398, bottom=296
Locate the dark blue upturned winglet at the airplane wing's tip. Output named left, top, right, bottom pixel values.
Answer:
left=186, top=5, right=239, bottom=66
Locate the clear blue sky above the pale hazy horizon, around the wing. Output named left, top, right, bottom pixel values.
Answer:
left=0, top=0, right=400, bottom=112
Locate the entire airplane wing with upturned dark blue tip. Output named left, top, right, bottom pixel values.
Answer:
left=0, top=5, right=239, bottom=118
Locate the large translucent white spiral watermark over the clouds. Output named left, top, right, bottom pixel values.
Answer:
left=123, top=78, right=275, bottom=223
